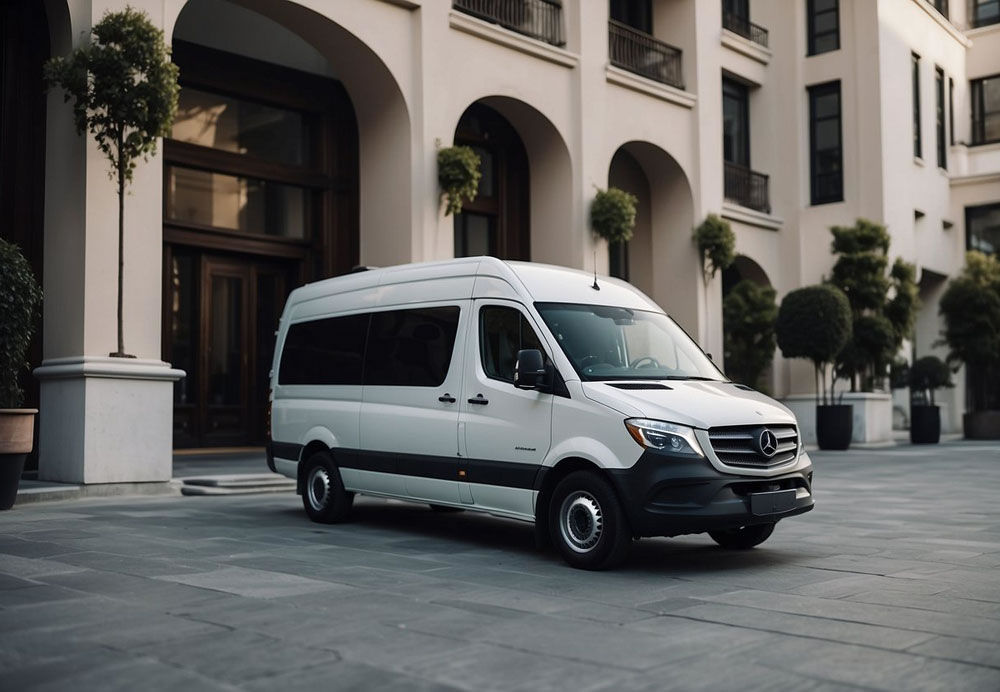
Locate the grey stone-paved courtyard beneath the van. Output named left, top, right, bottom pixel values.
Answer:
left=0, top=442, right=1000, bottom=692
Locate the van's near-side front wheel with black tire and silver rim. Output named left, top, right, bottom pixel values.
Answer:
left=548, top=471, right=632, bottom=570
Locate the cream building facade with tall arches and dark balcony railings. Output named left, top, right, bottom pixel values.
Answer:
left=5, top=0, right=1000, bottom=483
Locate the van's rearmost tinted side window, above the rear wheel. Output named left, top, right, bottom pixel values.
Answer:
left=278, top=314, right=369, bottom=384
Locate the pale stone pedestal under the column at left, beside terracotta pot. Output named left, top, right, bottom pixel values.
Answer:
left=35, top=356, right=184, bottom=483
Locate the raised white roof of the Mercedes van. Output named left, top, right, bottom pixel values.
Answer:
left=289, top=257, right=661, bottom=312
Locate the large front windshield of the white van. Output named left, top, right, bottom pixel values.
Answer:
left=535, top=303, right=728, bottom=382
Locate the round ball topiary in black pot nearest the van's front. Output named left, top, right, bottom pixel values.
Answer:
left=774, top=284, right=854, bottom=449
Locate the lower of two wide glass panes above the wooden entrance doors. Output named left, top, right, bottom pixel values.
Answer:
left=166, top=166, right=309, bottom=239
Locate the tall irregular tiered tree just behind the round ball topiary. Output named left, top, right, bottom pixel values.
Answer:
left=830, top=219, right=917, bottom=391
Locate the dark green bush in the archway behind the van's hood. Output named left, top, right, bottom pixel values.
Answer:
left=722, top=280, right=778, bottom=389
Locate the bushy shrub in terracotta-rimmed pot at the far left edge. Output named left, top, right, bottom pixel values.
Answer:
left=0, top=238, right=42, bottom=509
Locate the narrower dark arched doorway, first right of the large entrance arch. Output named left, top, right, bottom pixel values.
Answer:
left=454, top=103, right=531, bottom=260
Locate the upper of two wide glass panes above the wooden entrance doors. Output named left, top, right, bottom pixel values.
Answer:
left=170, top=87, right=307, bottom=165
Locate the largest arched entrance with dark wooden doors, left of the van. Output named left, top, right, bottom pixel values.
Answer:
left=163, top=0, right=359, bottom=447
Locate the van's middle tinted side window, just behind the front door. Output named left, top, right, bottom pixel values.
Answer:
left=364, top=306, right=459, bottom=387
